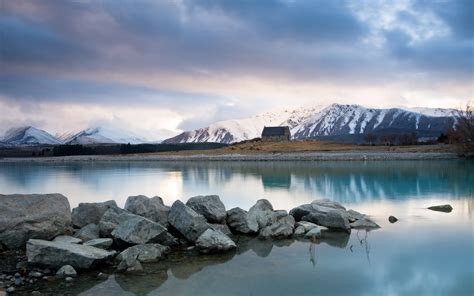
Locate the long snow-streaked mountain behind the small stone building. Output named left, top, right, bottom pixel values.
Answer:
left=164, top=104, right=454, bottom=143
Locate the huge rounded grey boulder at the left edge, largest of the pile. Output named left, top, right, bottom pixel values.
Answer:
left=0, top=194, right=71, bottom=249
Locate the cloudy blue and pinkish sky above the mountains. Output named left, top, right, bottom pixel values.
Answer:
left=0, top=0, right=474, bottom=140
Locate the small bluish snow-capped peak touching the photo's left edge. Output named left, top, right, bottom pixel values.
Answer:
left=0, top=126, right=62, bottom=146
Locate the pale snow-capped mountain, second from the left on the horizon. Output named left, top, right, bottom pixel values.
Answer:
left=58, top=127, right=146, bottom=145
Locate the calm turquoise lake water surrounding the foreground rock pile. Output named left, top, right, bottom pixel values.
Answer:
left=0, top=160, right=474, bottom=296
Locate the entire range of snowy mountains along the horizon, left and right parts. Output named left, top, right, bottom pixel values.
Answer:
left=0, top=104, right=455, bottom=147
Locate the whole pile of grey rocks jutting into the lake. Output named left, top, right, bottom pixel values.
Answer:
left=0, top=194, right=379, bottom=295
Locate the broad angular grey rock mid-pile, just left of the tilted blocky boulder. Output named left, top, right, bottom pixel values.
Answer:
left=112, top=214, right=171, bottom=245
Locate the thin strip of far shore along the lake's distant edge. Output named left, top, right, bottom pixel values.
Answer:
left=0, top=151, right=460, bottom=163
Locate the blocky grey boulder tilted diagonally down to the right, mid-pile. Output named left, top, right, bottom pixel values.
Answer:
left=168, top=200, right=210, bottom=242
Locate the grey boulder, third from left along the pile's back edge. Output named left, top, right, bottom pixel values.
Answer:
left=125, top=195, right=170, bottom=227
